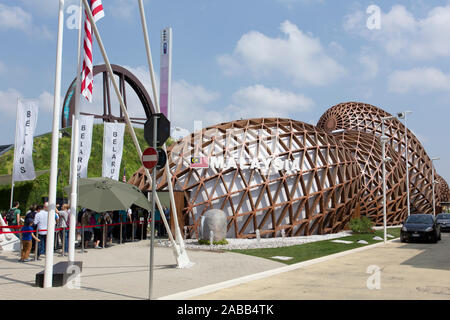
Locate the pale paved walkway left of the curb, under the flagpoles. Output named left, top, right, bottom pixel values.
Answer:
left=0, top=240, right=284, bottom=300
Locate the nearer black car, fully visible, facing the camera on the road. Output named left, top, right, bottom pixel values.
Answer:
left=400, top=214, right=441, bottom=243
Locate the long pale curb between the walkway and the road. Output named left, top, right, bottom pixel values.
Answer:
left=156, top=238, right=398, bottom=300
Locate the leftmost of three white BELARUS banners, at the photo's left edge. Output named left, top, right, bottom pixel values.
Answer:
left=13, top=100, right=39, bottom=181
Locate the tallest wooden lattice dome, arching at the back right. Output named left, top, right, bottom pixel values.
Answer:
left=317, top=102, right=433, bottom=213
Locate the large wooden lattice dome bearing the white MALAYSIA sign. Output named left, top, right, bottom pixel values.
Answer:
left=129, top=118, right=361, bottom=238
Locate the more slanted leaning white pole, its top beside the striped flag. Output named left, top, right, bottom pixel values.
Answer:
left=83, top=0, right=186, bottom=268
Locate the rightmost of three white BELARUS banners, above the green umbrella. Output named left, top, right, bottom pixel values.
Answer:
left=102, top=122, right=125, bottom=180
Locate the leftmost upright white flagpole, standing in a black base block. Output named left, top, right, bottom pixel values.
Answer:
left=44, top=0, right=64, bottom=288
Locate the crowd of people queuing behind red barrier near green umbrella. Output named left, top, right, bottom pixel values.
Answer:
left=2, top=202, right=170, bottom=262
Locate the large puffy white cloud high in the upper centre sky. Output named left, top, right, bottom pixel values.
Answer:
left=218, top=21, right=345, bottom=86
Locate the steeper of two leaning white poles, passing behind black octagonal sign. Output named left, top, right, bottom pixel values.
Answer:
left=139, top=0, right=191, bottom=265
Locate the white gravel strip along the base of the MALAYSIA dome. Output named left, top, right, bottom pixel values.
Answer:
left=155, top=231, right=352, bottom=251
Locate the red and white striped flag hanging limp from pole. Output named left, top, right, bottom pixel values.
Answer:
left=81, top=0, right=105, bottom=102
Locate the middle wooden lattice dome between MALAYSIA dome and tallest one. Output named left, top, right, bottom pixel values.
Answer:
left=332, top=130, right=408, bottom=226
